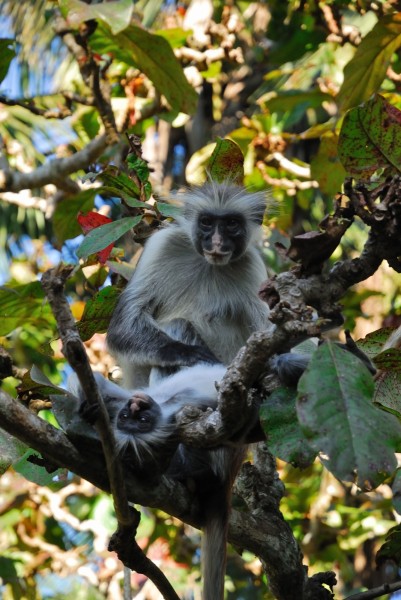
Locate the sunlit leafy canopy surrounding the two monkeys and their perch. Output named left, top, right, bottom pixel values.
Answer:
left=0, top=0, right=401, bottom=600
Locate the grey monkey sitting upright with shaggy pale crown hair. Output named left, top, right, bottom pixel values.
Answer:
left=107, top=181, right=269, bottom=388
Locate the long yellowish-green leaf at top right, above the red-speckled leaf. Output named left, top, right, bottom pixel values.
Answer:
left=337, top=12, right=401, bottom=111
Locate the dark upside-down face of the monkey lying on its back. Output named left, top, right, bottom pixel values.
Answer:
left=117, top=392, right=161, bottom=435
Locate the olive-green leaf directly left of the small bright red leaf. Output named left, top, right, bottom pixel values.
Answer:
left=53, top=189, right=99, bottom=243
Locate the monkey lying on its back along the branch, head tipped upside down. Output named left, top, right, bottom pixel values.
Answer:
left=69, top=358, right=253, bottom=600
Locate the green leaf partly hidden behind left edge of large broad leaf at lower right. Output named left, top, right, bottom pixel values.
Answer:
left=260, top=388, right=316, bottom=468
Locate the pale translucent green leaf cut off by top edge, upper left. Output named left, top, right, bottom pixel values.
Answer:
left=59, top=0, right=134, bottom=34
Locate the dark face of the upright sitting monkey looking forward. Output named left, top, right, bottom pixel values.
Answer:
left=195, top=212, right=247, bottom=266
